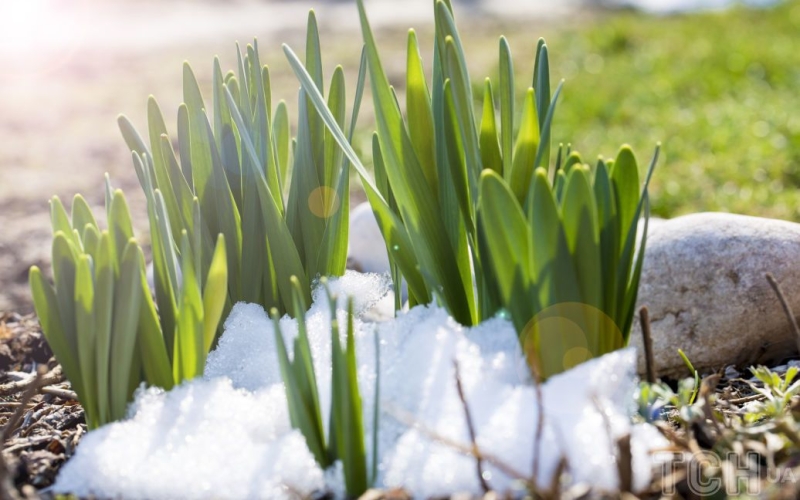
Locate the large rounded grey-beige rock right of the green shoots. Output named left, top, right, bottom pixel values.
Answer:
left=631, top=213, right=800, bottom=377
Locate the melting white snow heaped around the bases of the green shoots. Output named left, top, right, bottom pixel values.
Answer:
left=54, top=272, right=665, bottom=499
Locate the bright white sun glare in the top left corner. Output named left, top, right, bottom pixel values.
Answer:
left=0, top=0, right=83, bottom=76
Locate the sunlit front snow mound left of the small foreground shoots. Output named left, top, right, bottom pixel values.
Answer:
left=54, top=378, right=325, bottom=499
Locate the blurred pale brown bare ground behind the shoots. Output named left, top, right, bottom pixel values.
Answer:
left=0, top=0, right=574, bottom=314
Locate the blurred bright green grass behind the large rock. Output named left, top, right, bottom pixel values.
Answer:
left=548, top=1, right=800, bottom=221
